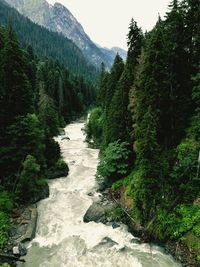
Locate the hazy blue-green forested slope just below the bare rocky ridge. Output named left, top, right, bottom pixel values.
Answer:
left=0, top=0, right=97, bottom=80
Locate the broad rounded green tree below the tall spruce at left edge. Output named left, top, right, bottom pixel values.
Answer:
left=0, top=114, right=45, bottom=186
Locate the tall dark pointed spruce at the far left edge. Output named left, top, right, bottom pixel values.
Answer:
left=0, top=25, right=33, bottom=131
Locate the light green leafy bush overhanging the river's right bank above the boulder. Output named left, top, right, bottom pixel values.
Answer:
left=97, top=141, right=131, bottom=180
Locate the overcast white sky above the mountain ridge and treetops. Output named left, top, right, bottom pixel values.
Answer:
left=47, top=0, right=170, bottom=49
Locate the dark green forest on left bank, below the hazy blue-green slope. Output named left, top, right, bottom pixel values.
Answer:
left=0, top=25, right=95, bottom=248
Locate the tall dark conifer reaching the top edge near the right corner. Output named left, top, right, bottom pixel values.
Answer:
left=162, top=0, right=192, bottom=147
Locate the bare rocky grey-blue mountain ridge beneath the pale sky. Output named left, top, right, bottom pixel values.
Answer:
left=6, top=0, right=126, bottom=68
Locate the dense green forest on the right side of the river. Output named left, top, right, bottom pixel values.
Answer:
left=86, top=0, right=200, bottom=260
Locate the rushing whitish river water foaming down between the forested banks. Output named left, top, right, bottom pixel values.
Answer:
left=20, top=123, right=181, bottom=267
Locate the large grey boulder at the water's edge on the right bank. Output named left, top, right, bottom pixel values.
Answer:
left=83, top=203, right=106, bottom=223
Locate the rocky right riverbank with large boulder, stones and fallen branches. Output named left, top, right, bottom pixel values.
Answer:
left=85, top=189, right=200, bottom=267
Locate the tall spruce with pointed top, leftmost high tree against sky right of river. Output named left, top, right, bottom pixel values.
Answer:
left=107, top=19, right=143, bottom=146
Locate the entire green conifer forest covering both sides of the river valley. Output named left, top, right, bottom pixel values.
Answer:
left=0, top=0, right=200, bottom=267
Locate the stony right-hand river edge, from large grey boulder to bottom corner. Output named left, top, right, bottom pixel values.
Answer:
left=84, top=189, right=200, bottom=267
